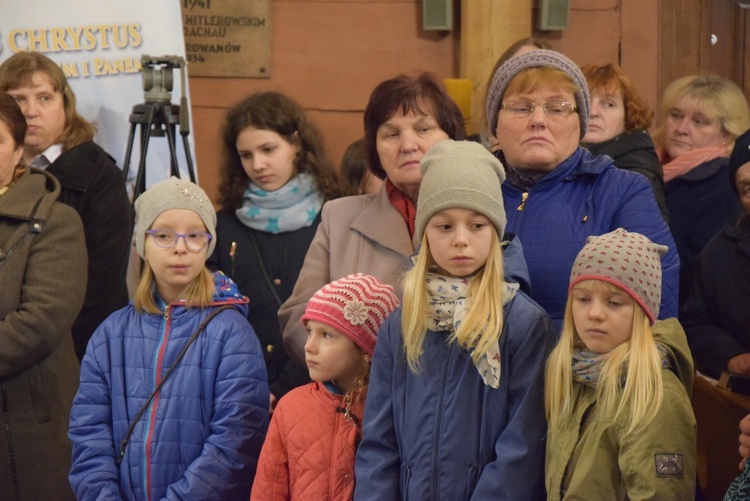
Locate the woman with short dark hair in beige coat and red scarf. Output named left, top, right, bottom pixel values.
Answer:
left=279, top=73, right=466, bottom=363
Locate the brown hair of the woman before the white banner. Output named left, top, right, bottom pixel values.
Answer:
left=0, top=52, right=96, bottom=151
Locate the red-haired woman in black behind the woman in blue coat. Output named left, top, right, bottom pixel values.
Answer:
left=581, top=63, right=669, bottom=221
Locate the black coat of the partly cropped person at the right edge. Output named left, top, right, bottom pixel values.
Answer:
left=680, top=216, right=750, bottom=378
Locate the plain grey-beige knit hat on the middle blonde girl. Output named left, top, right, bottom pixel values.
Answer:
left=416, top=139, right=507, bottom=240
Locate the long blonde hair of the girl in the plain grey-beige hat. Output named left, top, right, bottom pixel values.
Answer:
left=401, top=226, right=505, bottom=374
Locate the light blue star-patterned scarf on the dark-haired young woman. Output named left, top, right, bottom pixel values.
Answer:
left=235, top=172, right=323, bottom=233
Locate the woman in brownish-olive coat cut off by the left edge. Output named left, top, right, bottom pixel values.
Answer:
left=0, top=93, right=86, bottom=500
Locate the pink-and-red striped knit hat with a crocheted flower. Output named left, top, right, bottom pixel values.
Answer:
left=302, top=273, right=401, bottom=356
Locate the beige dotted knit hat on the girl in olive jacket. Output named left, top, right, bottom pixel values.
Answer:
left=568, top=228, right=667, bottom=325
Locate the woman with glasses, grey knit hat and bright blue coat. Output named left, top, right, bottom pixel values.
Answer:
left=487, top=50, right=679, bottom=327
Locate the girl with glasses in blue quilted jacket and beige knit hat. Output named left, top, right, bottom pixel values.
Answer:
left=68, top=177, right=269, bottom=500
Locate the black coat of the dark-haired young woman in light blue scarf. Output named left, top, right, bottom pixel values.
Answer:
left=207, top=211, right=320, bottom=398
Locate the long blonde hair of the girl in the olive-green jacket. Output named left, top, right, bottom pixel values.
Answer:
left=545, top=280, right=664, bottom=436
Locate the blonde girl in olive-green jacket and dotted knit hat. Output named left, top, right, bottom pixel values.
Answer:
left=545, top=228, right=696, bottom=500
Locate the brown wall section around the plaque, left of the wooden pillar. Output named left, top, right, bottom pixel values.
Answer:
left=190, top=0, right=458, bottom=200
